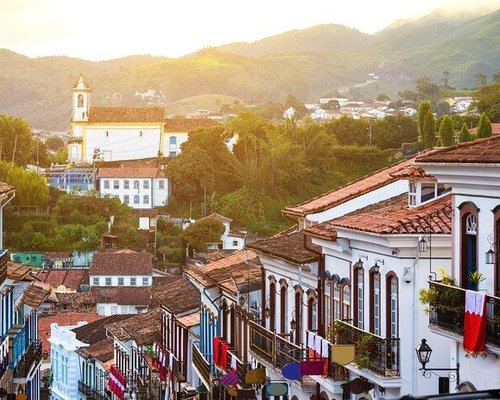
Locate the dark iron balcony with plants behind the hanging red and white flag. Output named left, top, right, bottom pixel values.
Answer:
left=428, top=282, right=500, bottom=348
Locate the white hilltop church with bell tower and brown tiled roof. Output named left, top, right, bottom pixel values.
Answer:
left=68, top=75, right=224, bottom=164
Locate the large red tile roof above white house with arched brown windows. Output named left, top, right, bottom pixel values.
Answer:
left=306, top=194, right=452, bottom=240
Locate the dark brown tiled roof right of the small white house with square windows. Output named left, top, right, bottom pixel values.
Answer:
left=151, top=276, right=201, bottom=314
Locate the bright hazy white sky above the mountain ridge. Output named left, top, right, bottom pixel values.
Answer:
left=0, top=0, right=500, bottom=61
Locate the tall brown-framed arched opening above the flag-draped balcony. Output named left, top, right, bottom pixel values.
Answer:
left=459, top=202, right=479, bottom=290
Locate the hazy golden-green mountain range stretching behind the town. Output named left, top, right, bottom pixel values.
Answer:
left=0, top=10, right=500, bottom=130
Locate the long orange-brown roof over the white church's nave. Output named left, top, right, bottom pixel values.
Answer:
left=89, top=107, right=165, bottom=123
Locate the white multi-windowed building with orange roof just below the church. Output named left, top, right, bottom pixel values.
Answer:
left=97, top=164, right=170, bottom=209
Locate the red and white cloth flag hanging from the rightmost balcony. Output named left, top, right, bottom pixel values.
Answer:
left=464, top=290, right=486, bottom=354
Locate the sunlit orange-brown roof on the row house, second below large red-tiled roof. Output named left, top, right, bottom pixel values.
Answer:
left=185, top=250, right=261, bottom=293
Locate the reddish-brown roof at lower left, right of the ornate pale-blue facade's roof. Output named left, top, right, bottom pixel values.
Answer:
left=106, top=307, right=161, bottom=345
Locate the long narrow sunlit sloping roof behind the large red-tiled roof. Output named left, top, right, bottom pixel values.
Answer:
left=283, top=158, right=415, bottom=218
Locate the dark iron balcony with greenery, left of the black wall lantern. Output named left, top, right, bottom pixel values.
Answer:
left=335, top=321, right=399, bottom=378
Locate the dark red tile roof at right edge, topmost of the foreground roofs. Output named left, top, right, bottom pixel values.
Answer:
left=416, top=135, right=500, bottom=164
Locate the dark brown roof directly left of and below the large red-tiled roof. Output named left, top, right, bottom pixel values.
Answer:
left=247, top=231, right=321, bottom=264
